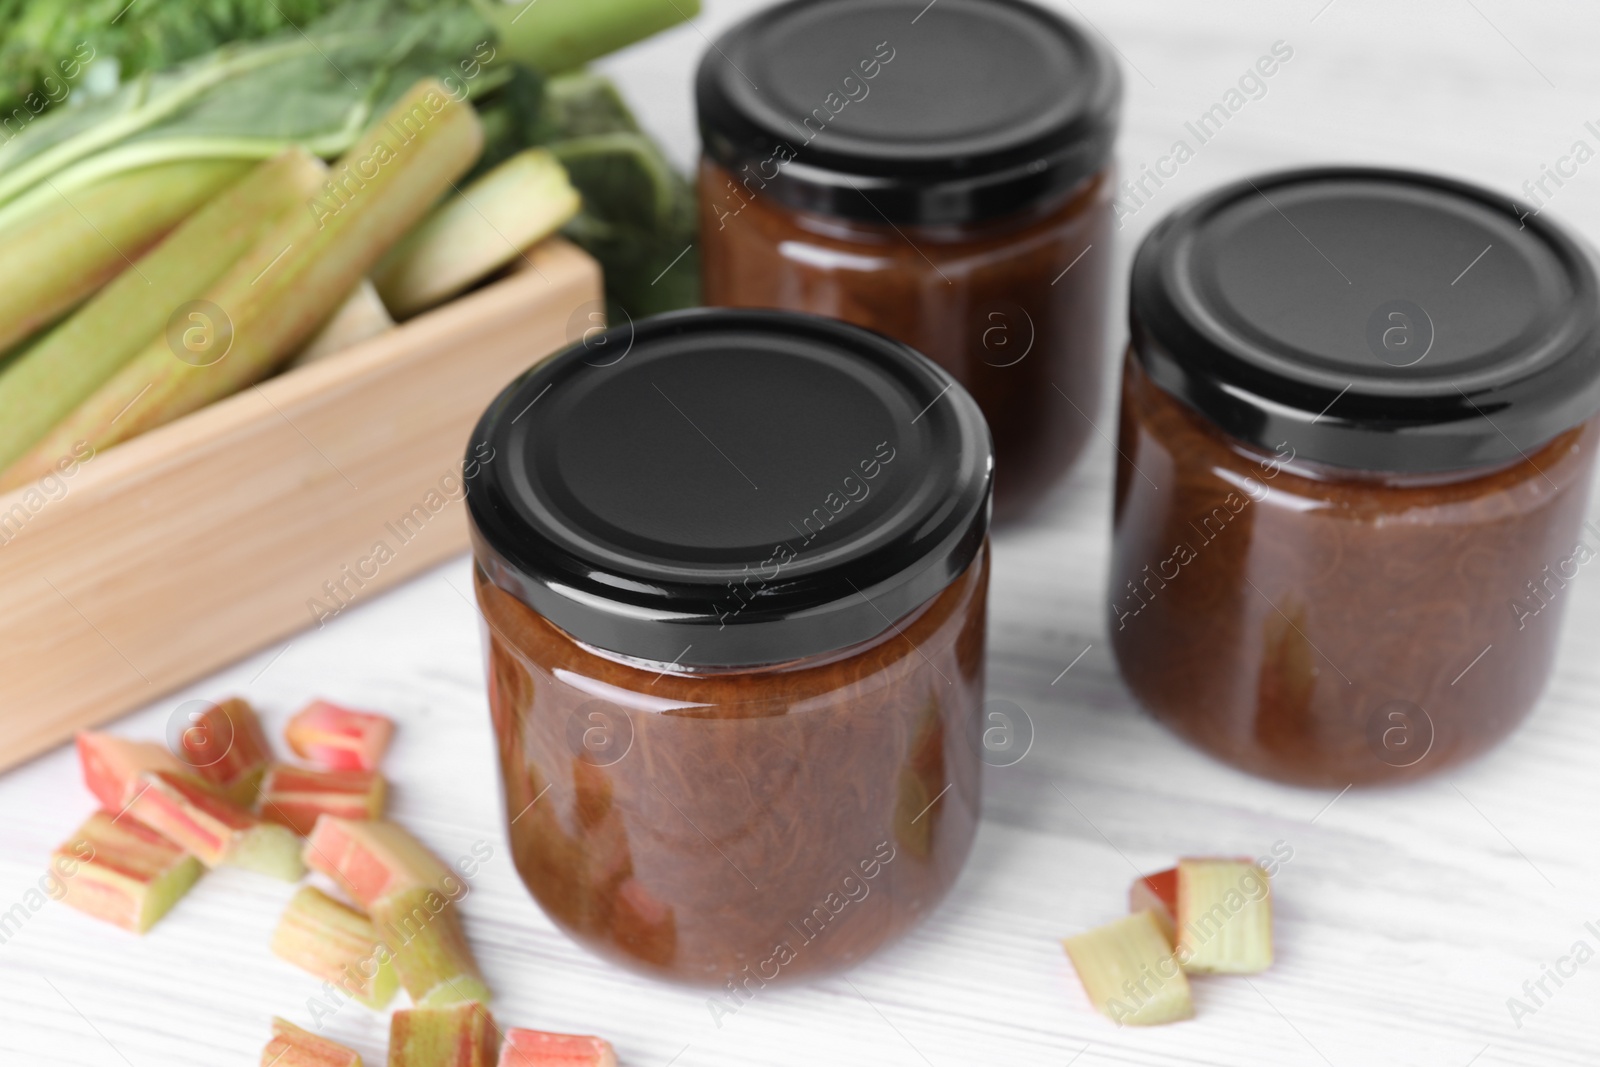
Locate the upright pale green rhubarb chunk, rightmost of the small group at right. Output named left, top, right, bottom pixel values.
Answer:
left=1178, top=859, right=1272, bottom=974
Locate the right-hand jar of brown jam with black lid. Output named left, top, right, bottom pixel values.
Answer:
left=1110, top=170, right=1600, bottom=787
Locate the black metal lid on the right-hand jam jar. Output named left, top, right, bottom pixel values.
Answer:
left=1130, top=168, right=1600, bottom=472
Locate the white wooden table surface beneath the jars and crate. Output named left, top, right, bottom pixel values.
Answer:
left=0, top=0, right=1600, bottom=1067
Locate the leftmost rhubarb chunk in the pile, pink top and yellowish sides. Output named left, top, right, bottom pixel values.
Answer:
left=50, top=811, right=202, bottom=934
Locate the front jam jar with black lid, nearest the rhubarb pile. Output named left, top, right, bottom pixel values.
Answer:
left=467, top=310, right=992, bottom=985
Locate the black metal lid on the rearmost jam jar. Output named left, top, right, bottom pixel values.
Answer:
left=696, top=0, right=1122, bottom=224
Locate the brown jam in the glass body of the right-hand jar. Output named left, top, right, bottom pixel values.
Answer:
left=1110, top=360, right=1600, bottom=787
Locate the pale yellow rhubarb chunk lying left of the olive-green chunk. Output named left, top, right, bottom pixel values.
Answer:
left=272, top=886, right=400, bottom=1011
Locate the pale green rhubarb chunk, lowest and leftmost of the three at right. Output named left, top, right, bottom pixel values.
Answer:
left=1061, top=912, right=1194, bottom=1027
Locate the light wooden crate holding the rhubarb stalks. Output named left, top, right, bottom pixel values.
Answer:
left=0, top=240, right=600, bottom=768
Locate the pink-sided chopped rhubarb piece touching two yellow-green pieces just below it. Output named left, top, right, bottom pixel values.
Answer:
left=306, top=816, right=456, bottom=910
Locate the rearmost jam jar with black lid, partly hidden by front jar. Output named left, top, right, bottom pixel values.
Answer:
left=696, top=0, right=1122, bottom=518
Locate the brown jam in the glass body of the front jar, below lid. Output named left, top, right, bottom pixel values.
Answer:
left=477, top=555, right=989, bottom=987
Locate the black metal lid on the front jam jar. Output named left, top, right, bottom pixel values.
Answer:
left=467, top=309, right=994, bottom=667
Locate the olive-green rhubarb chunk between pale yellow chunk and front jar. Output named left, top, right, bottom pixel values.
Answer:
left=373, top=888, right=490, bottom=1006
